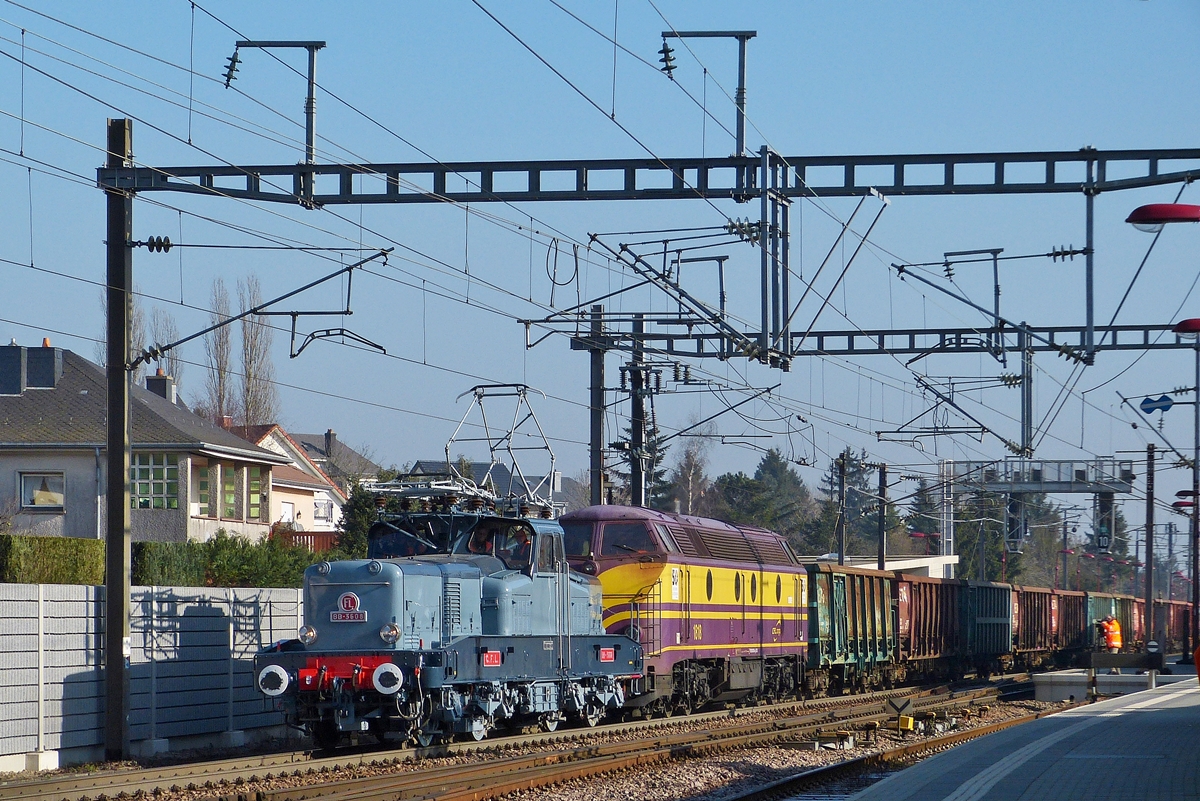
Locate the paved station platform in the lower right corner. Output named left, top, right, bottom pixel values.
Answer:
left=852, top=666, right=1200, bottom=801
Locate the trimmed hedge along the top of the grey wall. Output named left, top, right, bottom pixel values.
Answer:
left=0, top=531, right=328, bottom=588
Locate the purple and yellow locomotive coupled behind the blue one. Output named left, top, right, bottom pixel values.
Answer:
left=559, top=506, right=809, bottom=715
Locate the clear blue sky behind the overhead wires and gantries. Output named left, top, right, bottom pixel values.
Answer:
left=0, top=0, right=1200, bottom=544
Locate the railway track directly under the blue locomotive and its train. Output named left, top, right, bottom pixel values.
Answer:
left=0, top=687, right=997, bottom=801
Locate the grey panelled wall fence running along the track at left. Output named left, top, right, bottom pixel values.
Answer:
left=0, top=584, right=304, bottom=771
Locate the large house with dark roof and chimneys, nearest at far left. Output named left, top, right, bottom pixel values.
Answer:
left=0, top=341, right=288, bottom=542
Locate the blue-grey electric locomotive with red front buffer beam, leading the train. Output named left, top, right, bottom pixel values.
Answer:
left=256, top=481, right=642, bottom=747
